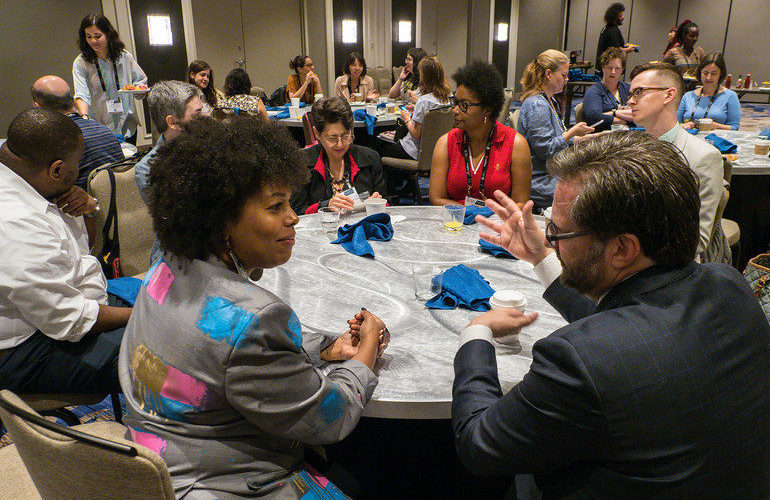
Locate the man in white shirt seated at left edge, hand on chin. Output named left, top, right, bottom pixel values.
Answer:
left=0, top=108, right=131, bottom=393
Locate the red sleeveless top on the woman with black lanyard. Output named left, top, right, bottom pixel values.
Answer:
left=446, top=123, right=516, bottom=205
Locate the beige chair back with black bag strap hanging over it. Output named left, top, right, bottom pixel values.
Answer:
left=88, top=164, right=155, bottom=276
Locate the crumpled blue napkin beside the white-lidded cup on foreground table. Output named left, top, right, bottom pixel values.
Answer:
left=425, top=264, right=495, bottom=312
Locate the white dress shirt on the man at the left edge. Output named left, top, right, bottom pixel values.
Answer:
left=0, top=163, right=107, bottom=349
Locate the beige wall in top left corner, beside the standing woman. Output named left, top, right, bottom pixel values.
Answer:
left=0, top=0, right=102, bottom=138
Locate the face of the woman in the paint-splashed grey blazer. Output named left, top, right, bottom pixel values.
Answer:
left=226, top=185, right=299, bottom=272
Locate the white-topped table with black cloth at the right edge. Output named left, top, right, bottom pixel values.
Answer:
left=698, top=130, right=770, bottom=271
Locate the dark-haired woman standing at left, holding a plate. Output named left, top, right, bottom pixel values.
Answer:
left=72, top=14, right=147, bottom=144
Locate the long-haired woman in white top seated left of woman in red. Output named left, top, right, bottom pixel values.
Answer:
left=377, top=56, right=451, bottom=160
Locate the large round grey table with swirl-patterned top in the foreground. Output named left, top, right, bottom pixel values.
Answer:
left=260, top=206, right=566, bottom=419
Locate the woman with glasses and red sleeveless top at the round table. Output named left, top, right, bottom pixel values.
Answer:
left=430, top=61, right=532, bottom=205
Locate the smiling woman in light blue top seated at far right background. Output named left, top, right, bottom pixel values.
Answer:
left=676, top=52, right=741, bottom=130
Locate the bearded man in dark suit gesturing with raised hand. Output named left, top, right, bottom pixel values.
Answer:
left=452, top=132, right=770, bottom=498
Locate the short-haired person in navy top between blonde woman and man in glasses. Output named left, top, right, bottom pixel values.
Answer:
left=583, top=47, right=633, bottom=132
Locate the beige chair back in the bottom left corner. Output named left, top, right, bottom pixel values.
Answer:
left=0, top=390, right=175, bottom=500
